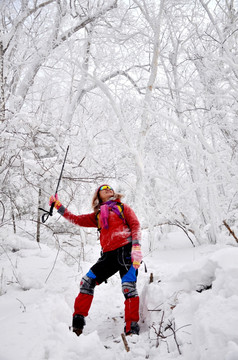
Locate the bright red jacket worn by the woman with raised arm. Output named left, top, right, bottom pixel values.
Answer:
left=63, top=204, right=141, bottom=252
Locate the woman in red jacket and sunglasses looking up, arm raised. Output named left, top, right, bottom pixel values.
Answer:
left=49, top=185, right=142, bottom=336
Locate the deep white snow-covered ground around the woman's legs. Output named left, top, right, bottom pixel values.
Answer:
left=0, top=224, right=238, bottom=360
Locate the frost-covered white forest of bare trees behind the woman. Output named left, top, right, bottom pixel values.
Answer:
left=0, top=0, right=238, bottom=249
